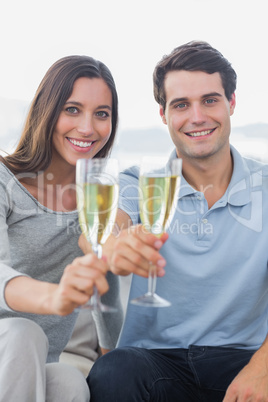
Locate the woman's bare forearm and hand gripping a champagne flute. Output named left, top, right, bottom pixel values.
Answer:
left=5, top=254, right=109, bottom=315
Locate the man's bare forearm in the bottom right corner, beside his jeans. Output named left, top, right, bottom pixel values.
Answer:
left=223, top=335, right=268, bottom=402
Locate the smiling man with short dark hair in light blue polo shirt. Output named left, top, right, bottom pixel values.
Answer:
left=88, top=42, right=268, bottom=402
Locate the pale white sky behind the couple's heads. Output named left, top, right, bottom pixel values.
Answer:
left=0, top=0, right=268, bottom=129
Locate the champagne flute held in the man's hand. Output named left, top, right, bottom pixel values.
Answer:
left=131, top=156, right=182, bottom=307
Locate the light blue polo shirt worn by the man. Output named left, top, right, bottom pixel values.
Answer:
left=118, top=147, right=268, bottom=349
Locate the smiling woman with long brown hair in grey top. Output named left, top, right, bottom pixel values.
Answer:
left=0, top=56, right=122, bottom=402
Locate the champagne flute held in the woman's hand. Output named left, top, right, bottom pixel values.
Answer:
left=76, top=158, right=119, bottom=312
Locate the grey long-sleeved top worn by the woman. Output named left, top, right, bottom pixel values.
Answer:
left=0, top=163, right=123, bottom=362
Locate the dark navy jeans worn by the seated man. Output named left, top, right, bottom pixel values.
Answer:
left=87, top=346, right=254, bottom=402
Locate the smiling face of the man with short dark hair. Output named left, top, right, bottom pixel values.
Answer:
left=160, top=70, right=235, bottom=159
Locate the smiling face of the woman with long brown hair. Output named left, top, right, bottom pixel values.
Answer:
left=52, top=77, right=112, bottom=166
